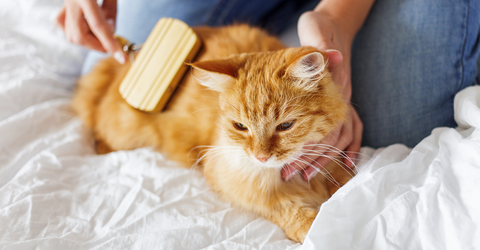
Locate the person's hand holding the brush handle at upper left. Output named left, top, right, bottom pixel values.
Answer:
left=56, top=0, right=126, bottom=64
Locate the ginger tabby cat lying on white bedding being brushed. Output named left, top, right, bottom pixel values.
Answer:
left=73, top=25, right=351, bottom=242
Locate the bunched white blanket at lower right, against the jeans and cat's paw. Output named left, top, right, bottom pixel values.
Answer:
left=302, top=86, right=480, bottom=250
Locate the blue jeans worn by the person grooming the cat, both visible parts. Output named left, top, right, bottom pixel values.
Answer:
left=84, top=0, right=480, bottom=147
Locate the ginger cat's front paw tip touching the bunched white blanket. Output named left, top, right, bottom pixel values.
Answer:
left=285, top=209, right=318, bottom=244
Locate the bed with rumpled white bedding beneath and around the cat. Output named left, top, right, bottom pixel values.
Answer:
left=0, top=0, right=480, bottom=249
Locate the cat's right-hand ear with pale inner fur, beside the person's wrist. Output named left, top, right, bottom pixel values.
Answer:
left=287, top=52, right=327, bottom=89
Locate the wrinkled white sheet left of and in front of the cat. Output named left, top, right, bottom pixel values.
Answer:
left=0, top=0, right=299, bottom=249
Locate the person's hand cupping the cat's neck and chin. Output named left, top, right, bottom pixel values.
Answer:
left=281, top=11, right=363, bottom=181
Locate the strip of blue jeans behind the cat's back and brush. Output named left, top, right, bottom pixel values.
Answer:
left=116, top=0, right=310, bottom=43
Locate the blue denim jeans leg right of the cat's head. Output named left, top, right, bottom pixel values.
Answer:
left=352, top=0, right=480, bottom=147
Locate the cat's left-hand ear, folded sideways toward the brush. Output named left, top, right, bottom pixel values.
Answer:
left=188, top=58, right=239, bottom=92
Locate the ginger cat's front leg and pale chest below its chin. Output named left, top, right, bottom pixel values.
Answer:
left=204, top=157, right=318, bottom=242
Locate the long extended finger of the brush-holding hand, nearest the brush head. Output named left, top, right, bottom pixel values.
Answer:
left=81, top=1, right=127, bottom=64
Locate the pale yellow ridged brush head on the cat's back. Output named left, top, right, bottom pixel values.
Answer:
left=120, top=18, right=201, bottom=112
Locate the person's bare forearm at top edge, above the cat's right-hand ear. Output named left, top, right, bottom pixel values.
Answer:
left=314, top=0, right=375, bottom=40
